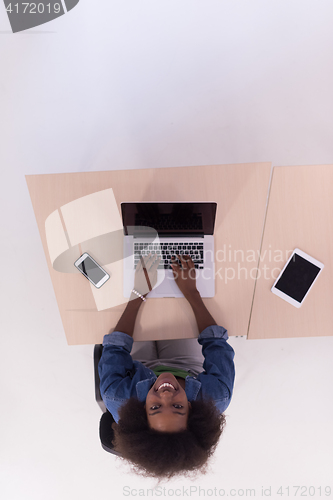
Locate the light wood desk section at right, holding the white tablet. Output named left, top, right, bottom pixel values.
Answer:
left=248, top=165, right=333, bottom=339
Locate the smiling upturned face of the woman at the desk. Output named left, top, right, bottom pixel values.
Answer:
left=145, top=373, right=191, bottom=432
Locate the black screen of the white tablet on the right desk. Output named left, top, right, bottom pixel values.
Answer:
left=275, top=253, right=320, bottom=302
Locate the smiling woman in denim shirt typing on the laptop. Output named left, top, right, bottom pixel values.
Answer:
left=99, top=255, right=235, bottom=478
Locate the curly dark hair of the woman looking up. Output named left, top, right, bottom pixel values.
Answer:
left=112, top=397, right=226, bottom=479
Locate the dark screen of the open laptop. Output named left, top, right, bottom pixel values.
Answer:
left=121, top=202, right=217, bottom=236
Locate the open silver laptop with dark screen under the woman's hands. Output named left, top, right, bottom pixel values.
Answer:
left=121, top=202, right=217, bottom=298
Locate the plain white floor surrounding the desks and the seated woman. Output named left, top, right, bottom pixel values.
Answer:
left=0, top=0, right=333, bottom=500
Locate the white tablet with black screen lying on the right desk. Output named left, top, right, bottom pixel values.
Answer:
left=271, top=248, right=324, bottom=307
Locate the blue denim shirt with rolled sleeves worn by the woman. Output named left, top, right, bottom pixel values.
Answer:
left=98, top=325, right=235, bottom=422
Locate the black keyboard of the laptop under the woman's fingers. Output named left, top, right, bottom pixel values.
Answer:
left=134, top=241, right=204, bottom=269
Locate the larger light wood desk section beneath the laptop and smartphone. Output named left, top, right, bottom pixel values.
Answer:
left=26, top=163, right=271, bottom=344
